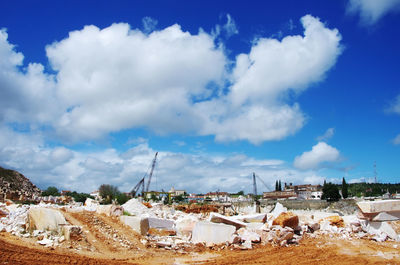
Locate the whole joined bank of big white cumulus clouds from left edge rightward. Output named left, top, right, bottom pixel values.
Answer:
left=0, top=15, right=342, bottom=144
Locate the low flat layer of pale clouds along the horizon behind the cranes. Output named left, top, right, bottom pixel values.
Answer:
left=0, top=127, right=332, bottom=193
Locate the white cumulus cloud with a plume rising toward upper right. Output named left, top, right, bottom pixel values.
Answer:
left=199, top=15, right=342, bottom=144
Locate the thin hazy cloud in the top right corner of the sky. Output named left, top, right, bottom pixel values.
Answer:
left=347, top=0, right=400, bottom=26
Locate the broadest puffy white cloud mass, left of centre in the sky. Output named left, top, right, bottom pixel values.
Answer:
left=46, top=24, right=225, bottom=139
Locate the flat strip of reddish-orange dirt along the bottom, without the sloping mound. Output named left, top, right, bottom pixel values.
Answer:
left=0, top=232, right=400, bottom=265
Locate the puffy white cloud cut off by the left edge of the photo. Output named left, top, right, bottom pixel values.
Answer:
left=0, top=29, right=61, bottom=124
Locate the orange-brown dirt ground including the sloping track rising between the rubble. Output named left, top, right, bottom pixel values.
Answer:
left=0, top=212, right=400, bottom=265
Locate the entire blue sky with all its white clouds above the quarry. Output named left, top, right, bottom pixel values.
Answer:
left=0, top=0, right=400, bottom=192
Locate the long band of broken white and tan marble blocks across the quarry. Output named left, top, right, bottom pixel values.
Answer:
left=0, top=199, right=400, bottom=251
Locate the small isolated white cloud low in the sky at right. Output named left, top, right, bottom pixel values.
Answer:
left=293, top=142, right=340, bottom=170
